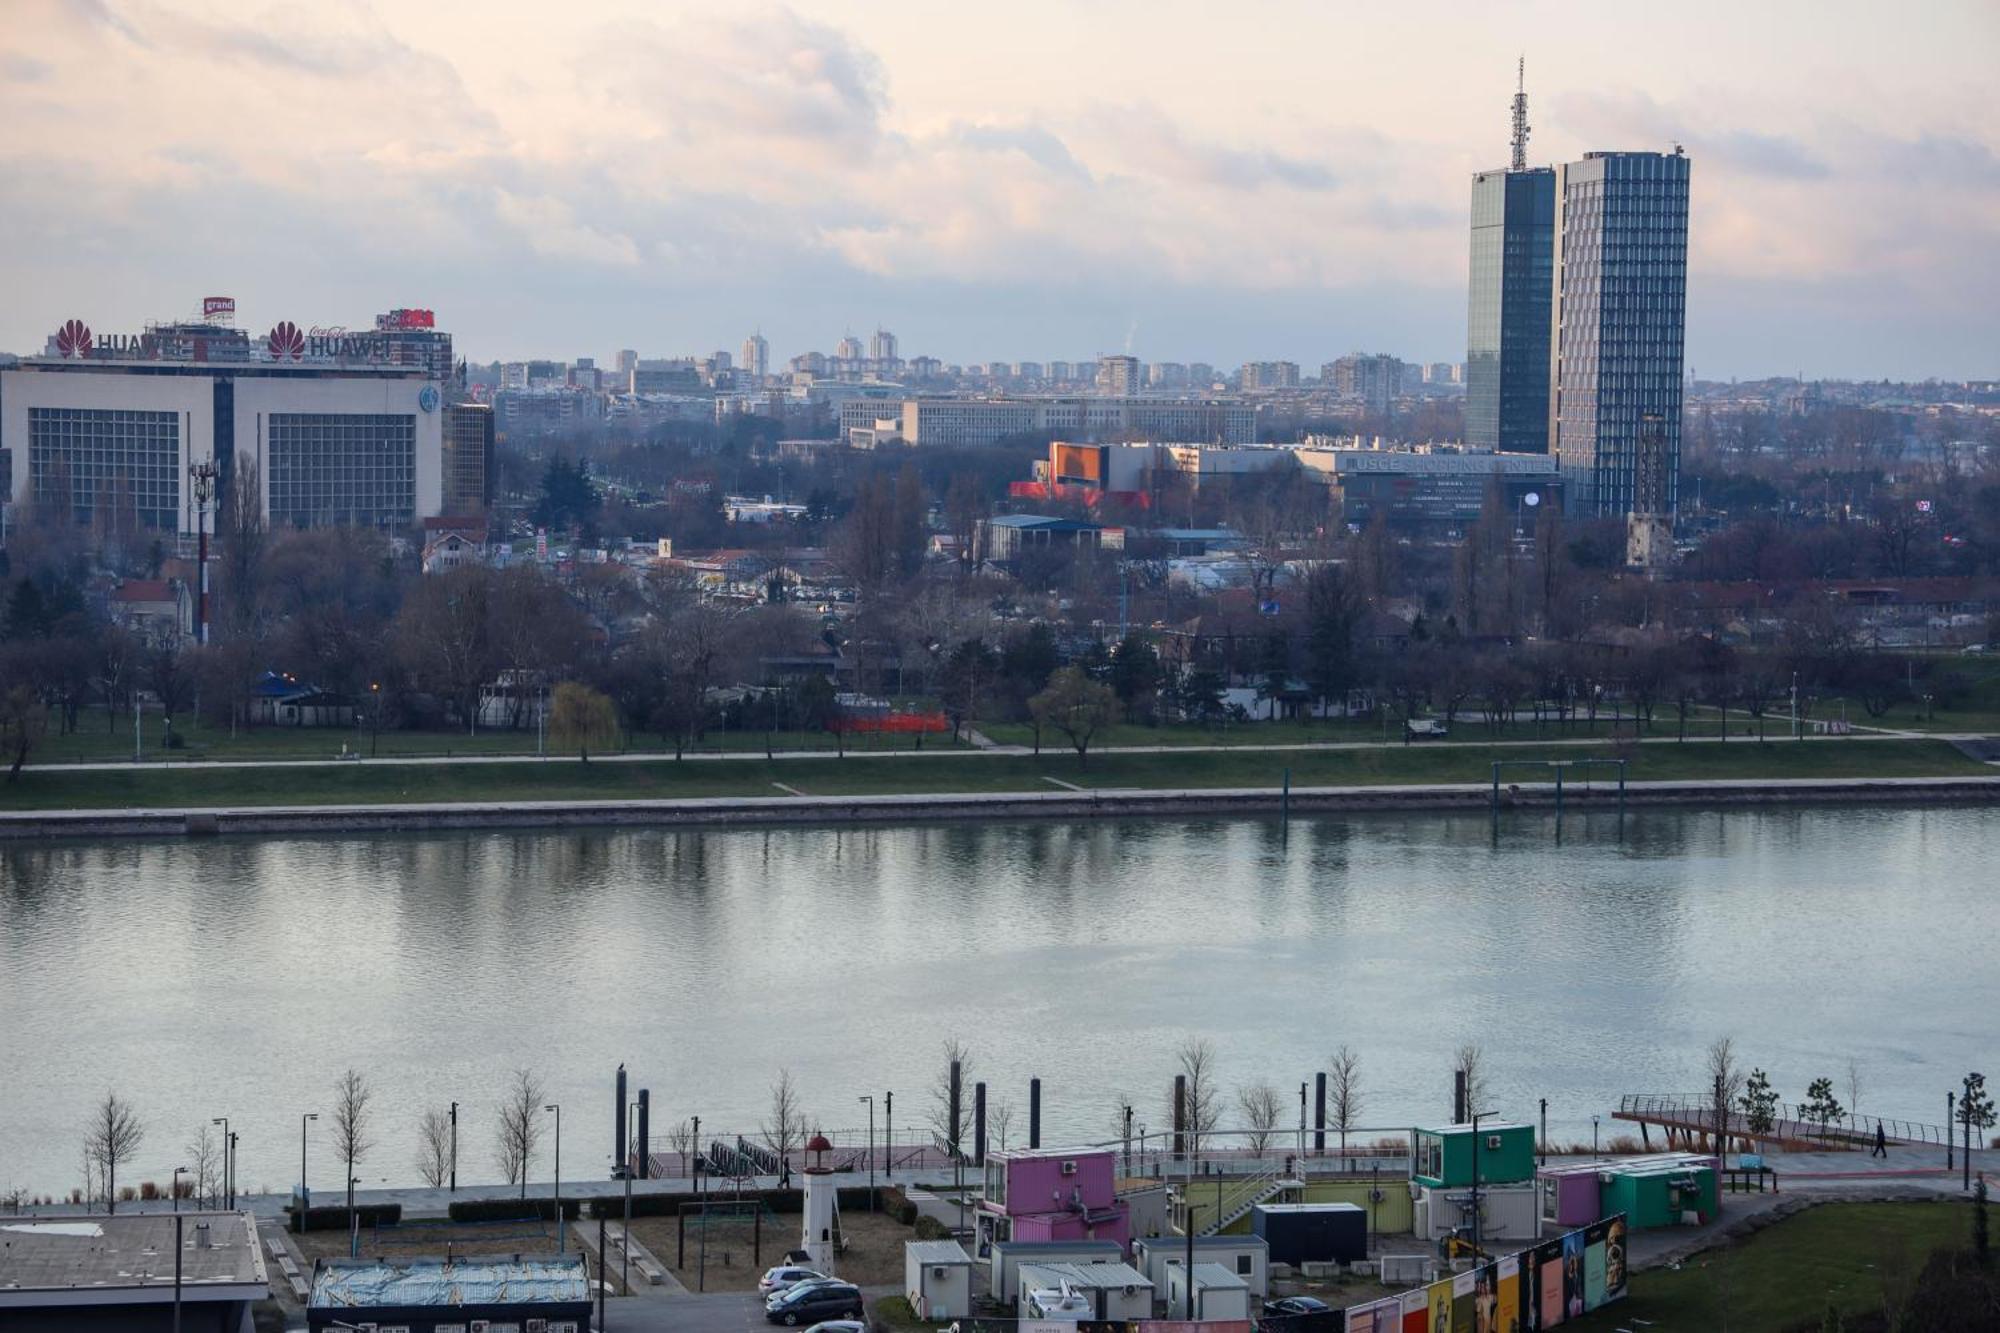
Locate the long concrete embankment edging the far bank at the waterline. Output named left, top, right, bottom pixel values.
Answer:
left=0, top=775, right=2000, bottom=841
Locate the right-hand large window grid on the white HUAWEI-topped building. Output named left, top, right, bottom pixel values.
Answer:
left=268, top=412, right=416, bottom=528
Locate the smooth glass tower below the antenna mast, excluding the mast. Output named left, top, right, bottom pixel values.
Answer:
left=1466, top=166, right=1556, bottom=454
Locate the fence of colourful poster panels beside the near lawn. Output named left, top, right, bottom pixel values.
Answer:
left=1346, top=1213, right=1626, bottom=1333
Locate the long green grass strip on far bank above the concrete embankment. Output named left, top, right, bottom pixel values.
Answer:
left=0, top=741, right=1976, bottom=809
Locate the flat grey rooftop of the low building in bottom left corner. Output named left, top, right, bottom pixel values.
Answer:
left=0, top=1213, right=268, bottom=1307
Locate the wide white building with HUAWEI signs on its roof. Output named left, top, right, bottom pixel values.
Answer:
left=0, top=298, right=460, bottom=532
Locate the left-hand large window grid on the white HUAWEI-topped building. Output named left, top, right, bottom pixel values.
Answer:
left=28, top=406, right=180, bottom=530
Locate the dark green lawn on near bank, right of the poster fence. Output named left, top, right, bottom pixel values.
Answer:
left=1564, top=1201, right=1972, bottom=1333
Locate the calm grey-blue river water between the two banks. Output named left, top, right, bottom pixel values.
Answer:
left=0, top=807, right=2000, bottom=1191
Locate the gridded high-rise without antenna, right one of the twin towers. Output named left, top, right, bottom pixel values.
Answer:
left=1550, top=148, right=1688, bottom=516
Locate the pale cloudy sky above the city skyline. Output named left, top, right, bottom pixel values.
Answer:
left=0, top=0, right=2000, bottom=378
